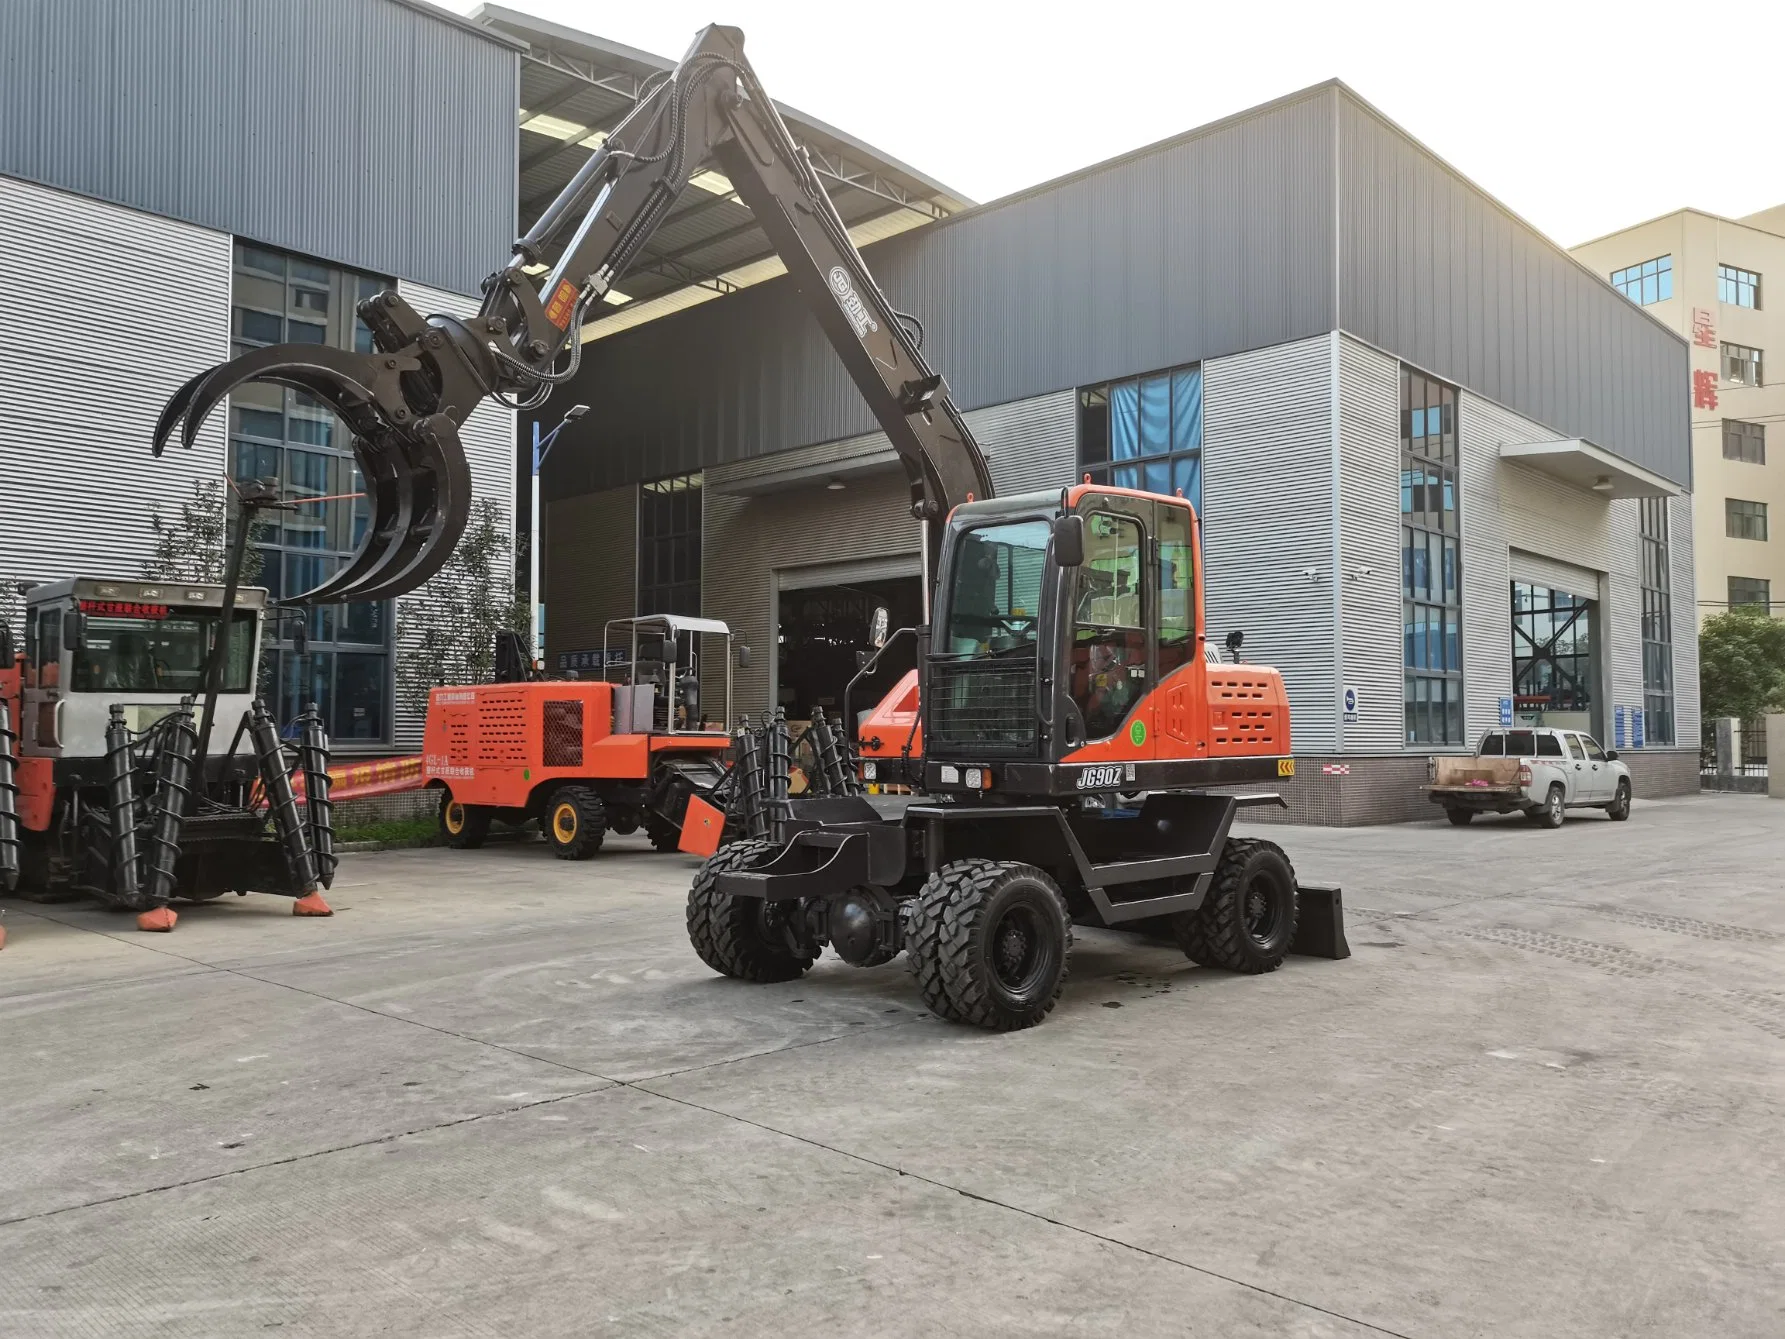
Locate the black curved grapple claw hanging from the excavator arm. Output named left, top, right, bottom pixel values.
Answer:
left=154, top=345, right=471, bottom=605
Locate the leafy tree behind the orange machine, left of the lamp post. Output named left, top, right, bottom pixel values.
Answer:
left=396, top=498, right=532, bottom=712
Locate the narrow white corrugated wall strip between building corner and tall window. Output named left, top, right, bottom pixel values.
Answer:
left=1333, top=336, right=1407, bottom=753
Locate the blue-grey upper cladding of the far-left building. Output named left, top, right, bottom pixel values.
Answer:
left=0, top=0, right=519, bottom=293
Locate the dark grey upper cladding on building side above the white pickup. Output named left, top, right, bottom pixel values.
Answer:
left=1337, top=91, right=1692, bottom=486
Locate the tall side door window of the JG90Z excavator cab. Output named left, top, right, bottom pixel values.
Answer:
left=1071, top=512, right=1146, bottom=741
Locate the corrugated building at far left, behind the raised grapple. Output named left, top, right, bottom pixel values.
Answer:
left=0, top=0, right=519, bottom=752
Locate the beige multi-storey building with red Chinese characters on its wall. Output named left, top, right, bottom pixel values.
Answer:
left=1573, top=205, right=1785, bottom=618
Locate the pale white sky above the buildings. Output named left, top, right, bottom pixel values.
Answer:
left=446, top=0, right=1785, bottom=245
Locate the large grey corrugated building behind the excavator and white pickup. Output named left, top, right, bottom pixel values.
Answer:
left=539, top=82, right=1698, bottom=821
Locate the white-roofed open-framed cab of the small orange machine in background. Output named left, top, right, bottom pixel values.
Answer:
left=602, top=614, right=732, bottom=734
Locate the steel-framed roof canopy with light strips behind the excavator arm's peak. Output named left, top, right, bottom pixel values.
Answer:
left=469, top=4, right=973, bottom=337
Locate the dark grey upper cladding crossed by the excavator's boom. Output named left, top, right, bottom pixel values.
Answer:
left=548, top=89, right=1335, bottom=496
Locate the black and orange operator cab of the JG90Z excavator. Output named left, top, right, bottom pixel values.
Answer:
left=923, top=482, right=1256, bottom=794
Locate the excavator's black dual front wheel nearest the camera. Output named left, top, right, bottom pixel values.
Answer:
left=905, top=861, right=1073, bottom=1032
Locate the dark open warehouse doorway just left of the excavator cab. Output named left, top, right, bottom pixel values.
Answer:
left=775, top=553, right=923, bottom=735
